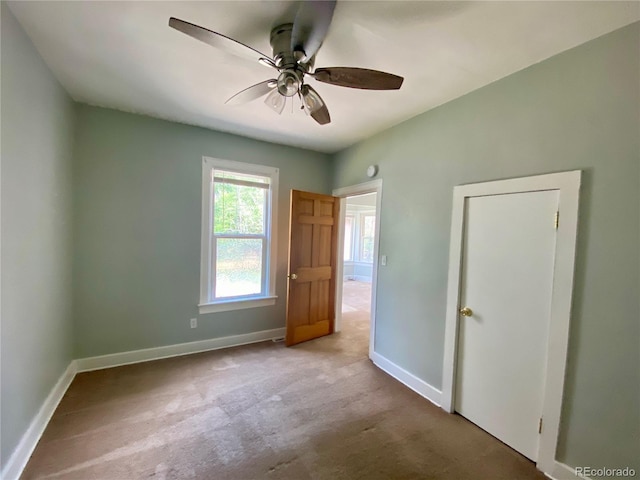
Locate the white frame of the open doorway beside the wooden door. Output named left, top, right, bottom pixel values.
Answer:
left=333, top=179, right=382, bottom=358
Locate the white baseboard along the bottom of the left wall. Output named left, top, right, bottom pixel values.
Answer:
left=0, top=360, right=76, bottom=480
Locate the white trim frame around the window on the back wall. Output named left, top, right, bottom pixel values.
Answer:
left=198, top=157, right=279, bottom=314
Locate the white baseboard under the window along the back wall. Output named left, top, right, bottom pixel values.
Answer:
left=76, top=328, right=285, bottom=372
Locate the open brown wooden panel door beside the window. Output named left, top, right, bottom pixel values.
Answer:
left=285, top=190, right=340, bottom=346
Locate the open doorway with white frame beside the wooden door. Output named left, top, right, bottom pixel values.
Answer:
left=333, top=180, right=382, bottom=357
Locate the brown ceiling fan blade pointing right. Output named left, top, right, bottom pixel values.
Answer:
left=310, top=67, right=404, bottom=90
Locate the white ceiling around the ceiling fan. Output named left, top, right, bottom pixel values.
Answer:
left=9, top=1, right=640, bottom=152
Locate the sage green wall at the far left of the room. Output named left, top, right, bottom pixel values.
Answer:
left=0, top=2, right=74, bottom=470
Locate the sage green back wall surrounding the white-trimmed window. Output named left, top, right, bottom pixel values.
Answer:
left=74, top=105, right=331, bottom=358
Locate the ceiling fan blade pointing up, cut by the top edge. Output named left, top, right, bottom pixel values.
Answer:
left=291, top=0, right=336, bottom=63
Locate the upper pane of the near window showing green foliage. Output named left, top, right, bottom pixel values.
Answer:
left=213, top=182, right=268, bottom=234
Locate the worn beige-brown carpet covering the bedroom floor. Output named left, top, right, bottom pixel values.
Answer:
left=22, top=284, right=545, bottom=480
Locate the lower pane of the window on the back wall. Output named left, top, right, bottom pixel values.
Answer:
left=215, top=238, right=263, bottom=298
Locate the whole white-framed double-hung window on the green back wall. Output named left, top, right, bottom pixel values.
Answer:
left=199, top=157, right=278, bottom=313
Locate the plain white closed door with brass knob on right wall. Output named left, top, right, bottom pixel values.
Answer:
left=455, top=190, right=558, bottom=461
